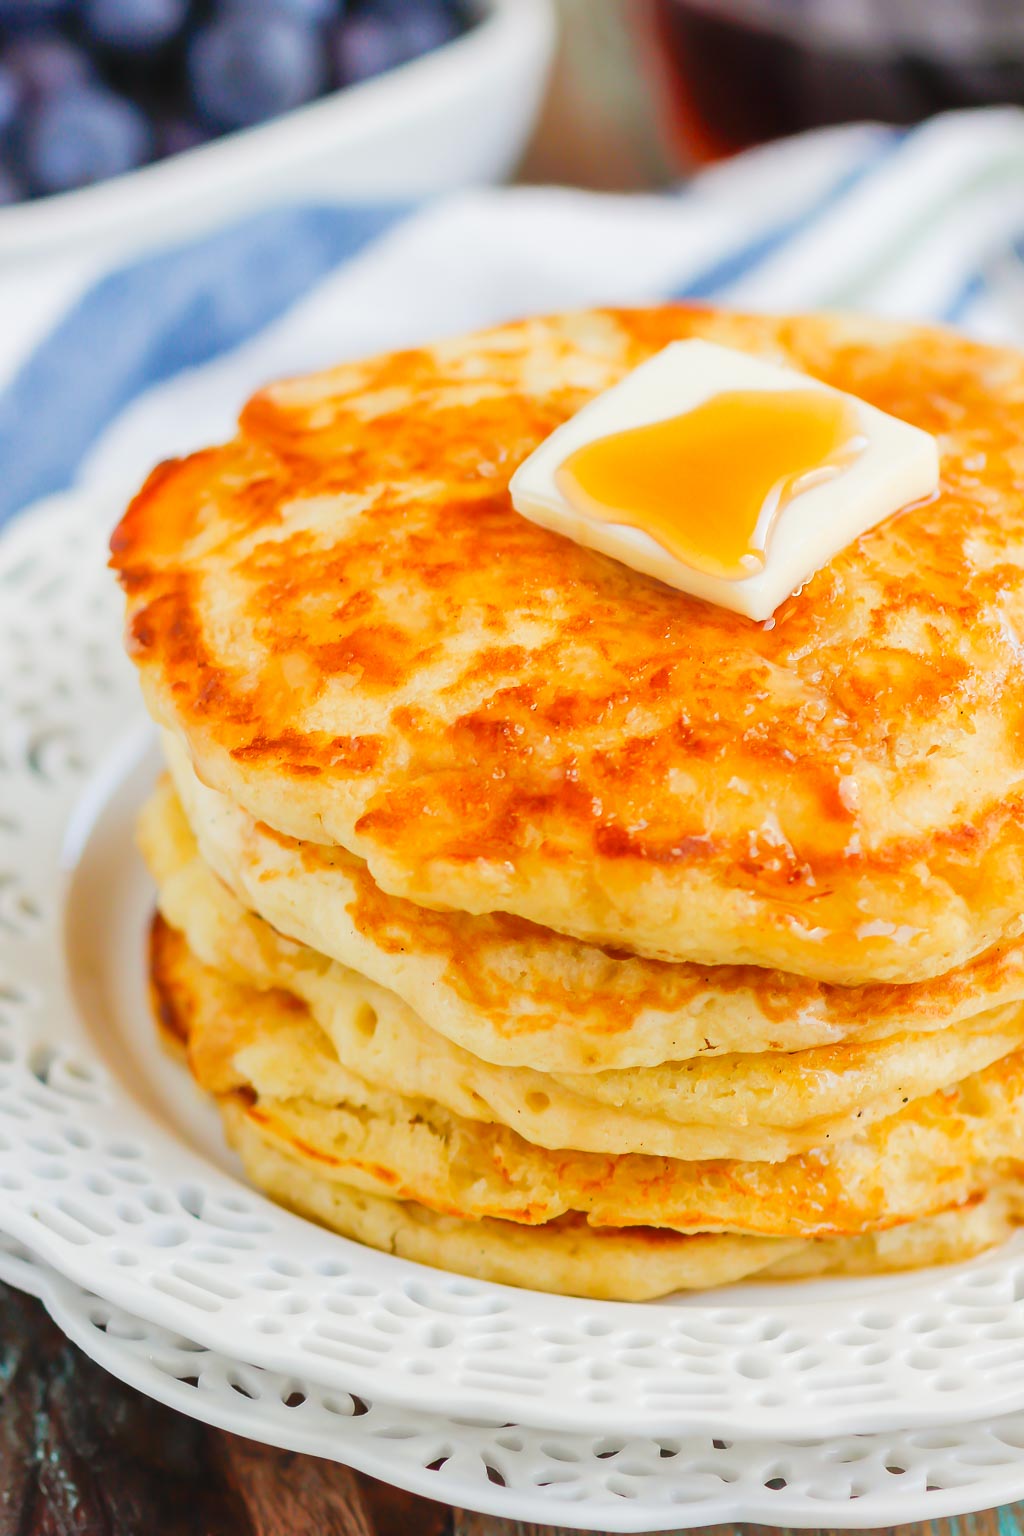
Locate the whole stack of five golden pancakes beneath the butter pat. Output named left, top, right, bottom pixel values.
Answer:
left=112, top=306, right=1024, bottom=1298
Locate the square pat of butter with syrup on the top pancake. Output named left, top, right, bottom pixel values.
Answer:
left=510, top=341, right=938, bottom=619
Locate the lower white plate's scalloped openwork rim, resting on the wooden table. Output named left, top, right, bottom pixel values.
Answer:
left=0, top=1238, right=1024, bottom=1531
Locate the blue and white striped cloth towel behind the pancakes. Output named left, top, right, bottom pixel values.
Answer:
left=0, top=109, right=1024, bottom=522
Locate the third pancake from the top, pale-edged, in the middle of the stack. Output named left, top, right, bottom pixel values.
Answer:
left=140, top=785, right=1024, bottom=1160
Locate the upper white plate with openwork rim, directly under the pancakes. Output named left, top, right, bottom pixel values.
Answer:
left=0, top=496, right=1024, bottom=1439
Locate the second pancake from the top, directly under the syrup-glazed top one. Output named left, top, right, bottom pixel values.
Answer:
left=155, top=734, right=1024, bottom=1074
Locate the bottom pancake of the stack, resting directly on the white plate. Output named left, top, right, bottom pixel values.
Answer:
left=152, top=923, right=1021, bottom=1301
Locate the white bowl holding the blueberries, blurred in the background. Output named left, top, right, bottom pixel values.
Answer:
left=0, top=0, right=554, bottom=263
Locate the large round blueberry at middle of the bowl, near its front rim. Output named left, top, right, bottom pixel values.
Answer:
left=189, top=11, right=324, bottom=127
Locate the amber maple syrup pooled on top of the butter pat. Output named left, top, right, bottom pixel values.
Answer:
left=554, top=389, right=866, bottom=581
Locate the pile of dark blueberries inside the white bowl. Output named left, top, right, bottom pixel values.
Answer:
left=0, top=0, right=473, bottom=203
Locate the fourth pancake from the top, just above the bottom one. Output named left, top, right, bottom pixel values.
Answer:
left=150, top=920, right=1024, bottom=1238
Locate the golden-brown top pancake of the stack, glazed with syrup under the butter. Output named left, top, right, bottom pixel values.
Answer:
left=105, top=307, right=1024, bottom=983
